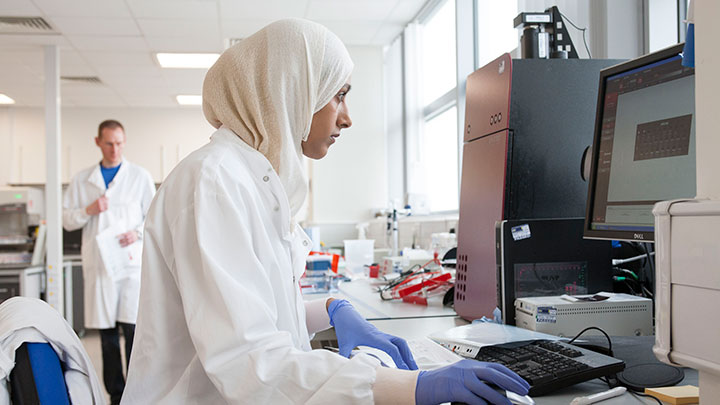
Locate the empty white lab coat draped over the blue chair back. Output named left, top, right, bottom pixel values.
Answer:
left=0, top=297, right=105, bottom=405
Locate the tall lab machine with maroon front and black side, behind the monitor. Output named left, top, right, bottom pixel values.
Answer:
left=455, top=54, right=621, bottom=319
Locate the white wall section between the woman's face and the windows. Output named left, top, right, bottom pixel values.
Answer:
left=310, top=47, right=388, bottom=224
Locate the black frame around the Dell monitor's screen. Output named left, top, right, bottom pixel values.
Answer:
left=583, top=43, right=685, bottom=242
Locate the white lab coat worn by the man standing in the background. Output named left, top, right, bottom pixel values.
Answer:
left=63, top=160, right=155, bottom=329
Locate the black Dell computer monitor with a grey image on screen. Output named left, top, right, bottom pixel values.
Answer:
left=584, top=44, right=696, bottom=242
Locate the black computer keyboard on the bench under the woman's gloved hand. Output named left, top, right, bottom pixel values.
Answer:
left=453, top=340, right=625, bottom=396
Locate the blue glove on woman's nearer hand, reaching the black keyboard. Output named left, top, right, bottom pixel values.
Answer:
left=415, top=360, right=530, bottom=405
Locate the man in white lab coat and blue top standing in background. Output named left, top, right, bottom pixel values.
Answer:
left=63, top=120, right=155, bottom=404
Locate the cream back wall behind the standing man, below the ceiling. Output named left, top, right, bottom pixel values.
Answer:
left=0, top=107, right=213, bottom=183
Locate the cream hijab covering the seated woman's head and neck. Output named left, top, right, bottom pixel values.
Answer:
left=203, top=19, right=353, bottom=217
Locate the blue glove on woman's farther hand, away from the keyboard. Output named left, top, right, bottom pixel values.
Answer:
left=328, top=300, right=417, bottom=370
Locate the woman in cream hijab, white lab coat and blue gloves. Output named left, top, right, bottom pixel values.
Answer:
left=123, top=19, right=528, bottom=404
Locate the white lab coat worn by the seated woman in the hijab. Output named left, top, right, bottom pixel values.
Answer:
left=123, top=128, right=382, bottom=404
